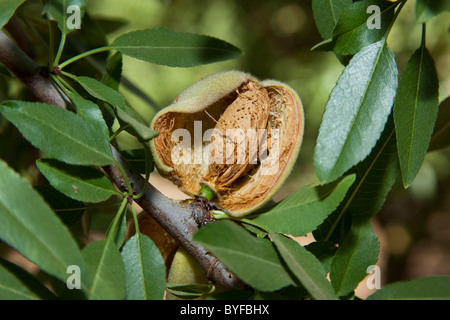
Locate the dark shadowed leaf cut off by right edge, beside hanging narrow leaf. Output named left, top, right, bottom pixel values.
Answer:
left=428, top=97, right=450, bottom=151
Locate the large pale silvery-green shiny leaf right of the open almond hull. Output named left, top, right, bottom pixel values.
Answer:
left=314, top=40, right=397, bottom=183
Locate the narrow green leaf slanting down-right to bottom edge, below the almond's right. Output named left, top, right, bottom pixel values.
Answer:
left=270, top=232, right=336, bottom=300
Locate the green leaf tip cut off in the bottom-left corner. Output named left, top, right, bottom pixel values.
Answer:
left=0, top=259, right=56, bottom=300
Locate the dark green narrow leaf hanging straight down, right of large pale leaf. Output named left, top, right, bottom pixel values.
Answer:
left=394, top=45, right=439, bottom=188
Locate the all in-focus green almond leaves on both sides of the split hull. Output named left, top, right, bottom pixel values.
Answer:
left=0, top=0, right=450, bottom=299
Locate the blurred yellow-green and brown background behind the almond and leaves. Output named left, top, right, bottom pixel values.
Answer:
left=0, top=0, right=450, bottom=296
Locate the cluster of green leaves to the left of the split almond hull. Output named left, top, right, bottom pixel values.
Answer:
left=0, top=0, right=241, bottom=299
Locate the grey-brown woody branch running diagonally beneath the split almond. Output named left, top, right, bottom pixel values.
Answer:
left=0, top=30, right=244, bottom=289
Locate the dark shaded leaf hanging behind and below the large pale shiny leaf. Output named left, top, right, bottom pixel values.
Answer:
left=314, top=116, right=400, bottom=243
